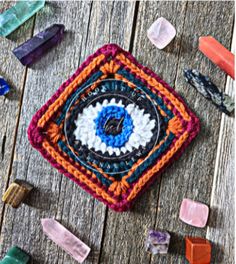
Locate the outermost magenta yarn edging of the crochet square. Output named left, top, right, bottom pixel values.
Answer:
left=27, top=44, right=200, bottom=212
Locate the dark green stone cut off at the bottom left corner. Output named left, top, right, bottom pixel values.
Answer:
left=0, top=246, right=31, bottom=264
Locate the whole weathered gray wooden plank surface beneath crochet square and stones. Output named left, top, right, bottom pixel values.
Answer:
left=0, top=1, right=234, bottom=264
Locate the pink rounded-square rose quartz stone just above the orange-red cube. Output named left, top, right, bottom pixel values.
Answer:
left=179, top=199, right=209, bottom=227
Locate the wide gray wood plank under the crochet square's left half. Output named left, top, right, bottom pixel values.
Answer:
left=1, top=1, right=135, bottom=264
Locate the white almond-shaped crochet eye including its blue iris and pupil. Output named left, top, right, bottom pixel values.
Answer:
left=73, top=99, right=156, bottom=156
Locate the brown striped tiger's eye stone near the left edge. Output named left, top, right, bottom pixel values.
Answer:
left=2, top=179, right=33, bottom=208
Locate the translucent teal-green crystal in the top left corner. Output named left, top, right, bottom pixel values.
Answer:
left=0, top=0, right=45, bottom=37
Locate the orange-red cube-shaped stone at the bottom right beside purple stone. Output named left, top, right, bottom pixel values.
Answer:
left=185, top=237, right=211, bottom=264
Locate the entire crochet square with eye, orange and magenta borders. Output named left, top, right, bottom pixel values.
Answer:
left=28, top=44, right=199, bottom=211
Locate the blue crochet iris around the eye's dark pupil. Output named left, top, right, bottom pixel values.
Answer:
left=94, top=105, right=134, bottom=148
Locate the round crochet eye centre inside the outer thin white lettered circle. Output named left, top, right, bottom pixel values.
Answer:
left=65, top=79, right=160, bottom=175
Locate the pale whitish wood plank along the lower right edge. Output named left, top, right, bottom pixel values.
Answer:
left=207, top=27, right=236, bottom=264
